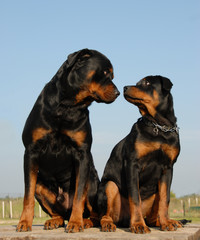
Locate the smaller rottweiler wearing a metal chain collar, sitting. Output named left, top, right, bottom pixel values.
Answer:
left=98, top=76, right=181, bottom=233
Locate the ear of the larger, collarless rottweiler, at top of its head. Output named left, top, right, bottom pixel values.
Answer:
left=67, top=48, right=92, bottom=68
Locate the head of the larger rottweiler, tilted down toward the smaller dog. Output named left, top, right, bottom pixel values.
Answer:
left=57, top=49, right=119, bottom=104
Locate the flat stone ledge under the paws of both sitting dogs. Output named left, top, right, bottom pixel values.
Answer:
left=0, top=224, right=200, bottom=240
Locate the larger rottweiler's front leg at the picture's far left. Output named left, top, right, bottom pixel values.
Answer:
left=16, top=150, right=38, bottom=232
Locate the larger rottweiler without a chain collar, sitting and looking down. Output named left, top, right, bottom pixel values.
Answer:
left=17, top=49, right=119, bottom=232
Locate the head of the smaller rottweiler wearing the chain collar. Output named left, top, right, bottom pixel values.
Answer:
left=124, top=76, right=173, bottom=117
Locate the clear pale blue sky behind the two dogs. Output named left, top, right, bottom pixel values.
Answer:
left=0, top=0, right=200, bottom=196
